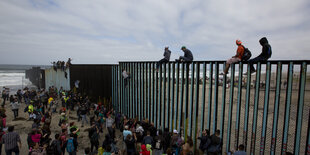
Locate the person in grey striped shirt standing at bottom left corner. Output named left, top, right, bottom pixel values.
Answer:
left=1, top=126, right=22, bottom=155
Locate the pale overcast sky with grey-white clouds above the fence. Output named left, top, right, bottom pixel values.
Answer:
left=0, top=0, right=310, bottom=65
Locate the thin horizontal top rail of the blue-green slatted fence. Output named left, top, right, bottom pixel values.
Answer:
left=119, top=60, right=310, bottom=64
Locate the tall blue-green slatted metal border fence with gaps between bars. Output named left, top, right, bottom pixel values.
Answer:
left=112, top=60, right=310, bottom=154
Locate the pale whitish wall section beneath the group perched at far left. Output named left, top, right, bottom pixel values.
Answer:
left=45, top=68, right=70, bottom=90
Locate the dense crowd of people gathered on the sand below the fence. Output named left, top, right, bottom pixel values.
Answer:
left=0, top=87, right=251, bottom=155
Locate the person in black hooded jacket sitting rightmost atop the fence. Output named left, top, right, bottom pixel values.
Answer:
left=249, top=37, right=272, bottom=73
